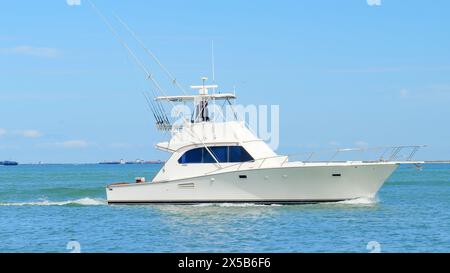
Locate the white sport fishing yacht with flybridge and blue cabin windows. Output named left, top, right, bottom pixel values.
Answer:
left=106, top=81, right=420, bottom=204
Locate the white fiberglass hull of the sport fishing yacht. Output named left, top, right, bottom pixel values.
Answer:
left=106, top=163, right=398, bottom=204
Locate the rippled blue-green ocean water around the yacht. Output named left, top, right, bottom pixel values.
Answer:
left=0, top=164, right=450, bottom=252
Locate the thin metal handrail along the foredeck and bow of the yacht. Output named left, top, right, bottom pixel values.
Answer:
left=205, top=145, right=427, bottom=175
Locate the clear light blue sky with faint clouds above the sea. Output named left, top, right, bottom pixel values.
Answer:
left=0, top=0, right=450, bottom=162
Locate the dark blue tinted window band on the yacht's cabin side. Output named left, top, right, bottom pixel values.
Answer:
left=178, top=146, right=254, bottom=164
